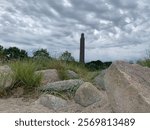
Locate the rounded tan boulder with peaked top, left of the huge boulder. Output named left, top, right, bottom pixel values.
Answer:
left=74, top=82, right=101, bottom=107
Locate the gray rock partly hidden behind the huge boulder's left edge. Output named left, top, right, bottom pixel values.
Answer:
left=94, top=70, right=106, bottom=90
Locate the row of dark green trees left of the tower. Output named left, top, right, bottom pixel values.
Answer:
left=0, top=45, right=75, bottom=61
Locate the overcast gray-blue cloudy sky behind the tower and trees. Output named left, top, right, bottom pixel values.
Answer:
left=0, top=0, right=150, bottom=61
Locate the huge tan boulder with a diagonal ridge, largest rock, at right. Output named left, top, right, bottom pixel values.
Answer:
left=104, top=61, right=150, bottom=112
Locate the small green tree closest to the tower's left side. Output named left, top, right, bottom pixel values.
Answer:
left=59, top=51, right=75, bottom=61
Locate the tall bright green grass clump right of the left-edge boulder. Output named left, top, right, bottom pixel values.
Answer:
left=11, top=61, right=42, bottom=89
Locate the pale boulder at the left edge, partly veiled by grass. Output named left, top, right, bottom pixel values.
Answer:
left=0, top=65, right=13, bottom=88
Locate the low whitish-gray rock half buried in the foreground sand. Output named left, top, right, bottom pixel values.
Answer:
left=39, top=94, right=67, bottom=111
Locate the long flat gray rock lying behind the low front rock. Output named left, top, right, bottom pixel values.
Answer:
left=40, top=79, right=84, bottom=91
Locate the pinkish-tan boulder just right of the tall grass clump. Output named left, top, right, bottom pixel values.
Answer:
left=36, top=69, right=60, bottom=85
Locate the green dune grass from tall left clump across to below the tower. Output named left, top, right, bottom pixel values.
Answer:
left=6, top=59, right=98, bottom=93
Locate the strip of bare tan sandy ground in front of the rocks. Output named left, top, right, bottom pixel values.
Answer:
left=0, top=91, right=112, bottom=113
